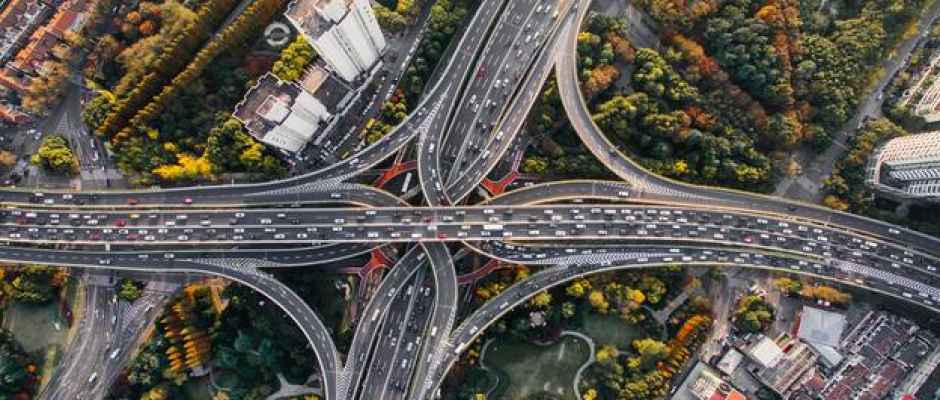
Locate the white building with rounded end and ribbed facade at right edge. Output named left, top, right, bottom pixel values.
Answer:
left=866, top=131, right=940, bottom=201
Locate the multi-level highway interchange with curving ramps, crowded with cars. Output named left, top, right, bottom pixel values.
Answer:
left=11, top=0, right=940, bottom=400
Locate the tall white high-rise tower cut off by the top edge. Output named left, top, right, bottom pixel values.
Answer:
left=286, top=0, right=385, bottom=82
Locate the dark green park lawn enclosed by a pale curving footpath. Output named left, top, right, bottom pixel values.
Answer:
left=483, top=336, right=589, bottom=400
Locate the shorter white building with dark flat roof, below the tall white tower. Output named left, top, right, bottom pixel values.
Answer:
left=232, top=66, right=352, bottom=153
